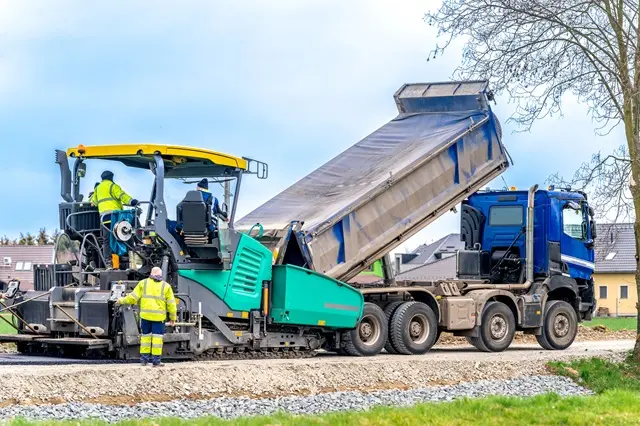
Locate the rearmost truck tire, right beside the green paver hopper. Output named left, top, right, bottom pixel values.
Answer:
left=342, top=303, right=389, bottom=356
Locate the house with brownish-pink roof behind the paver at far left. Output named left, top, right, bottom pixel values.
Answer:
left=0, top=245, right=55, bottom=290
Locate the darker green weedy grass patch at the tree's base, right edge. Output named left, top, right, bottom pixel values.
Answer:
left=549, top=352, right=640, bottom=395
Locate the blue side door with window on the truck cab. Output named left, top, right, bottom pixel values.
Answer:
left=559, top=200, right=595, bottom=279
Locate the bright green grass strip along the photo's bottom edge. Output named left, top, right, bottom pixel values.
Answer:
left=0, top=390, right=640, bottom=426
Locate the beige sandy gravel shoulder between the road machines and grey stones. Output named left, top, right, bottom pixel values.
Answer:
left=0, top=340, right=633, bottom=407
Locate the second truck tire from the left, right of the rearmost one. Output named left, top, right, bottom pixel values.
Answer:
left=389, top=302, right=438, bottom=355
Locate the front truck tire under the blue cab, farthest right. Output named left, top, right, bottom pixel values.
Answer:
left=536, top=300, right=578, bottom=350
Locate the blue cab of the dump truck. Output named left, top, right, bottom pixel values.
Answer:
left=458, top=187, right=596, bottom=320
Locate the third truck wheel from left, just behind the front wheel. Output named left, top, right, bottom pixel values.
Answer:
left=474, top=302, right=516, bottom=352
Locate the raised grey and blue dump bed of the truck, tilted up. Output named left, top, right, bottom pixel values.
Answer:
left=236, top=81, right=509, bottom=281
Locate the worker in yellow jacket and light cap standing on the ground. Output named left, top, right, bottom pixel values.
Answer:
left=117, top=267, right=177, bottom=367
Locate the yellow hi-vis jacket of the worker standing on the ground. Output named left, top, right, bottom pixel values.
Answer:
left=120, top=278, right=177, bottom=321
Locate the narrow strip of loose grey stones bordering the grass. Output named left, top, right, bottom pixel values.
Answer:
left=0, top=376, right=591, bottom=422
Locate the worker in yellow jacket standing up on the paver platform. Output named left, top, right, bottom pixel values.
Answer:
left=89, top=170, right=138, bottom=269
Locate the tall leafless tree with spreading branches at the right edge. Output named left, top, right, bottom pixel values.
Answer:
left=425, top=0, right=640, bottom=360
